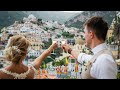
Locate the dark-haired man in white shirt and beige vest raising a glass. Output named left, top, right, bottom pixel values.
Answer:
left=62, top=17, right=117, bottom=79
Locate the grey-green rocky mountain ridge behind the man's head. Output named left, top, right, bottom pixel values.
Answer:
left=65, top=11, right=116, bottom=28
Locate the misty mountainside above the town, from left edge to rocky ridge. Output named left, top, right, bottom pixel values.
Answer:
left=0, top=11, right=75, bottom=29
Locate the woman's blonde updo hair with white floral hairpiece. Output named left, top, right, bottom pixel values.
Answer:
left=4, top=35, right=30, bottom=64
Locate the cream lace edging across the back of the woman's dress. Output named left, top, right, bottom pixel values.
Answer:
left=0, top=65, right=36, bottom=79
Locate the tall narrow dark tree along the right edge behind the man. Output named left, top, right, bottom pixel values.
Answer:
left=113, top=12, right=120, bottom=59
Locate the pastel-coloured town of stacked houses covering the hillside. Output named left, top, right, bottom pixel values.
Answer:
left=0, top=14, right=120, bottom=78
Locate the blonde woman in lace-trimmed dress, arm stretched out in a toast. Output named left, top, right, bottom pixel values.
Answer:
left=0, top=35, right=57, bottom=79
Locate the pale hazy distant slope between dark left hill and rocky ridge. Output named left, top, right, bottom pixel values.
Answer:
left=24, top=11, right=75, bottom=24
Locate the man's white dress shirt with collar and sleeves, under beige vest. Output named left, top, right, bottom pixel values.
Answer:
left=77, top=43, right=117, bottom=79
